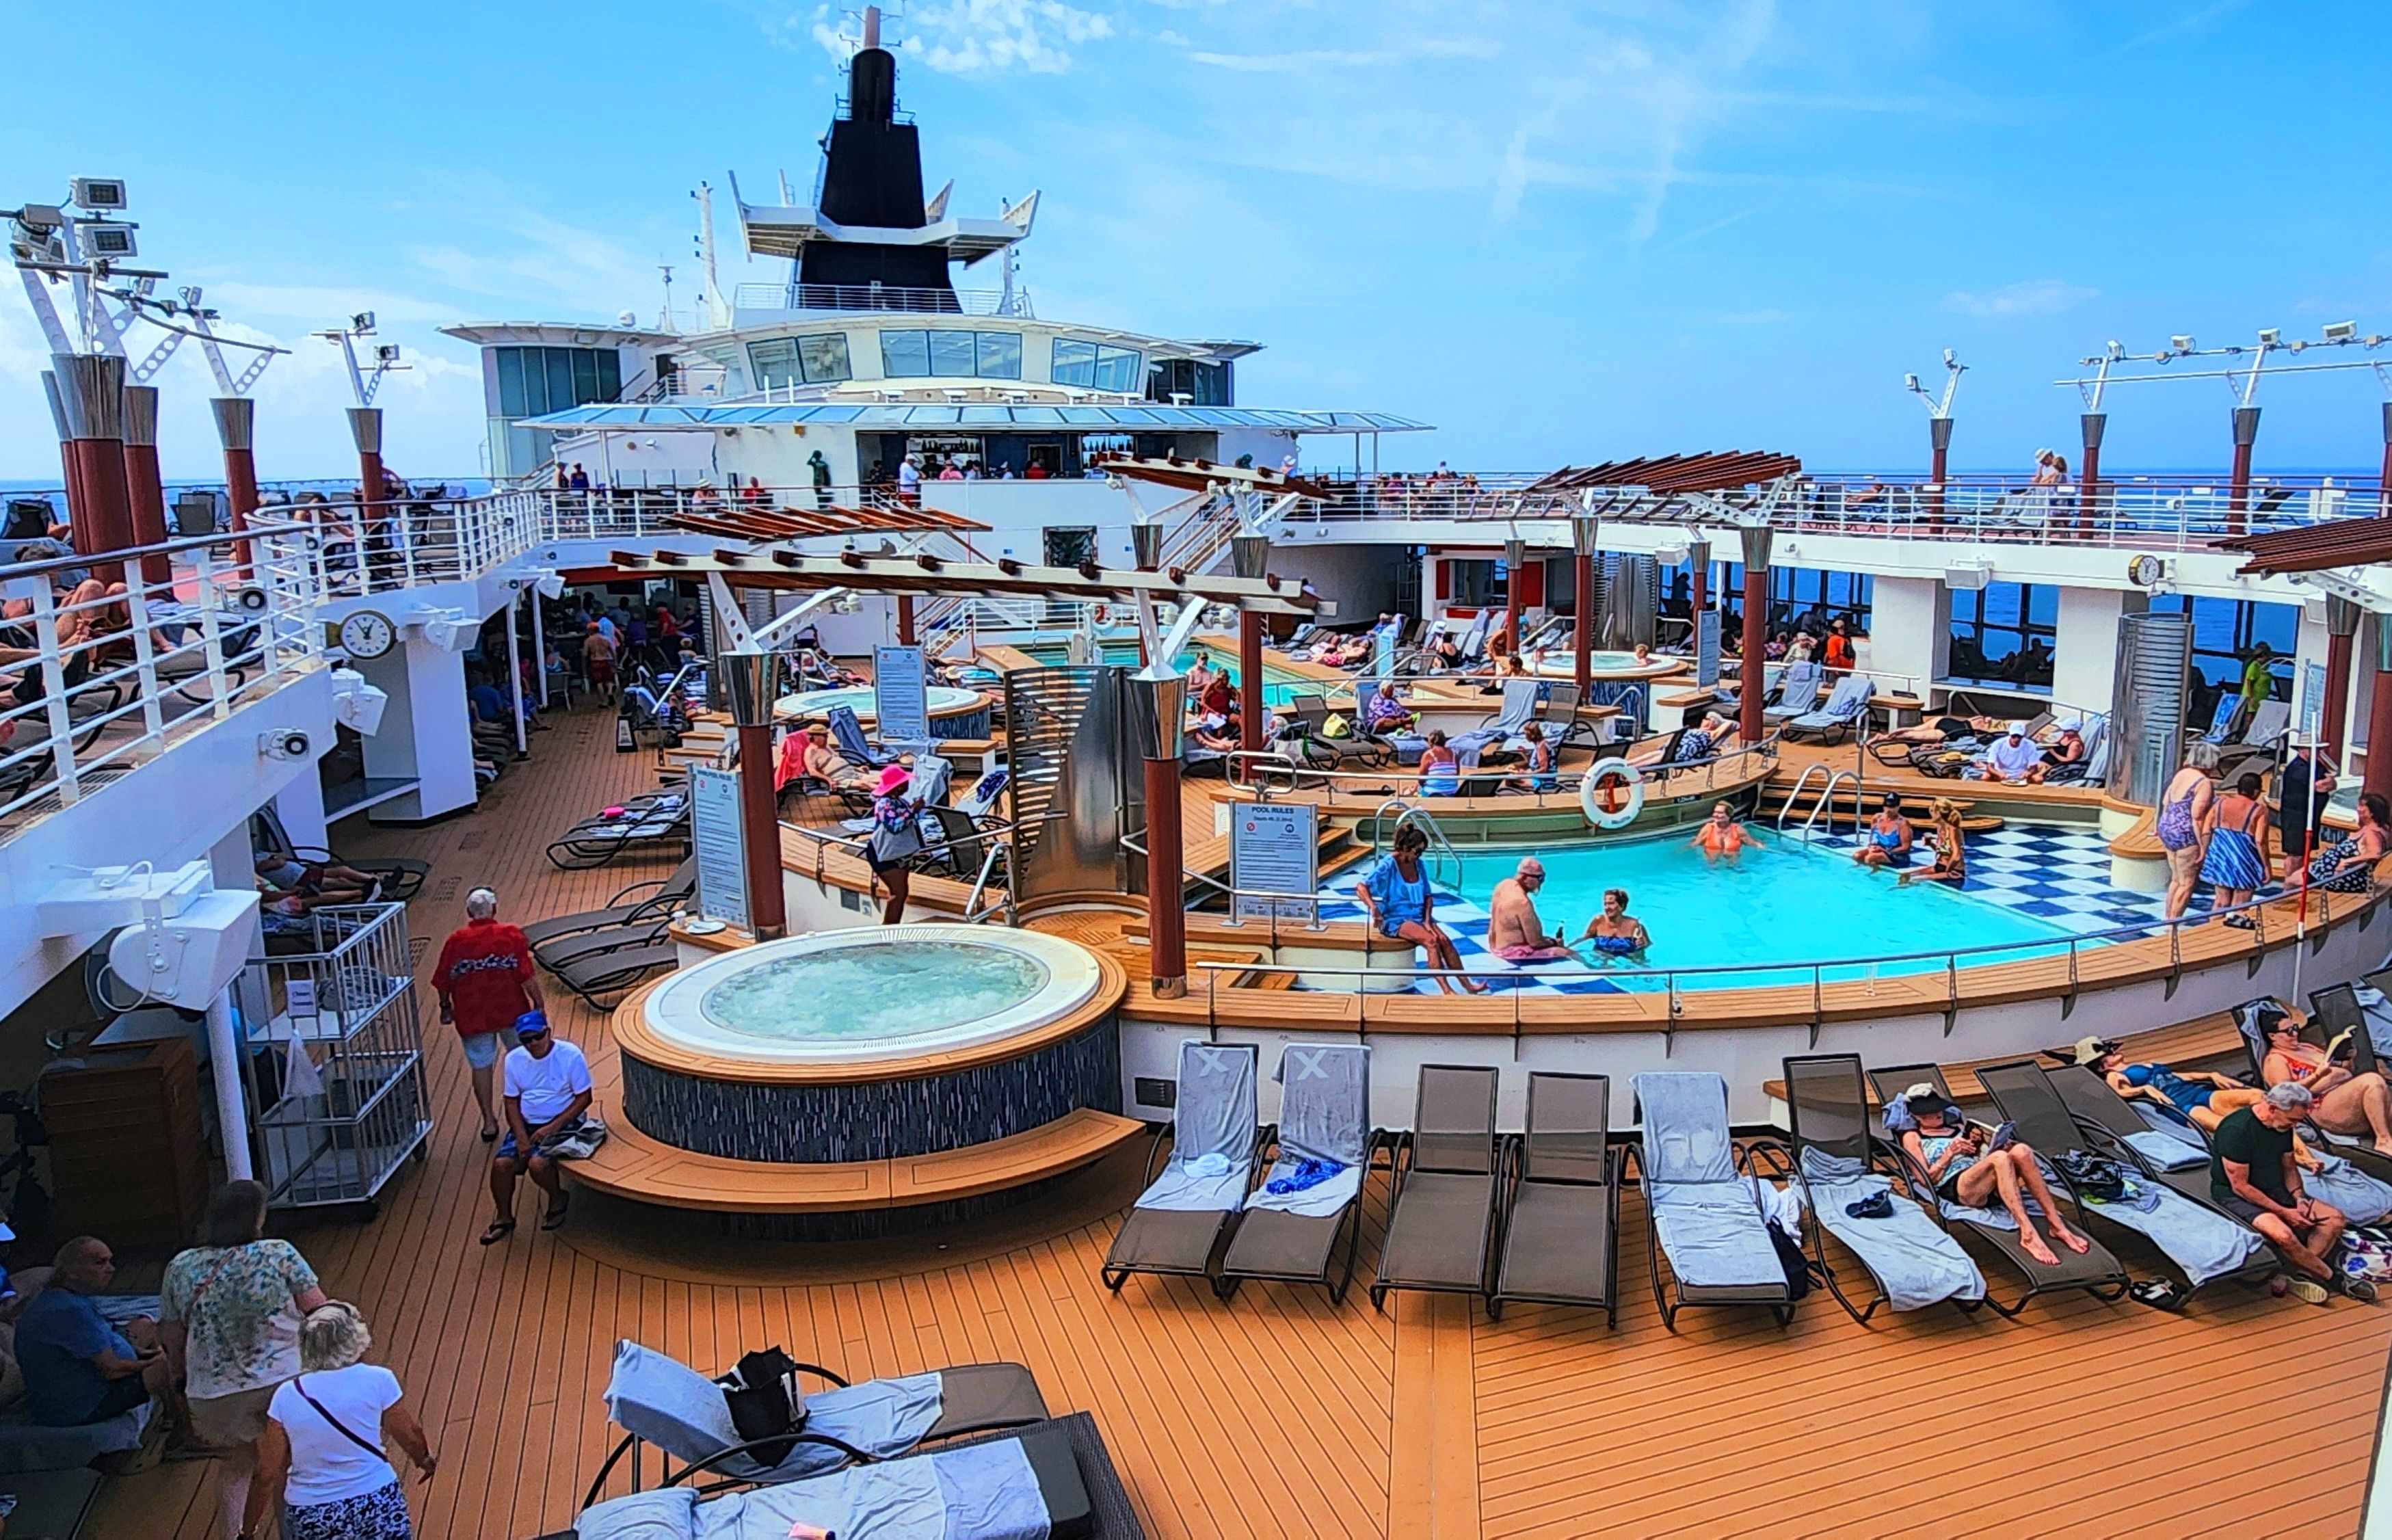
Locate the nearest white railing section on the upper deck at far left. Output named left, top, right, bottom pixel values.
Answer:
left=0, top=535, right=323, bottom=822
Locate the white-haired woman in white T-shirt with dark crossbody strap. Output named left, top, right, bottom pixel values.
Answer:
left=241, top=1299, right=440, bottom=1540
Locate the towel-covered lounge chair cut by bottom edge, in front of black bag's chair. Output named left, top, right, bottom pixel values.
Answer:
left=569, top=1411, right=1146, bottom=1540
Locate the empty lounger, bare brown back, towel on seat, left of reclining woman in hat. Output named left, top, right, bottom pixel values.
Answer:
left=1785, top=1054, right=1985, bottom=1325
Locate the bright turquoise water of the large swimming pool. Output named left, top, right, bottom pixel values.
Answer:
left=1461, top=829, right=2069, bottom=990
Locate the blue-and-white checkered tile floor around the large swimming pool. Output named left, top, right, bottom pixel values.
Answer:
left=1320, top=823, right=2248, bottom=995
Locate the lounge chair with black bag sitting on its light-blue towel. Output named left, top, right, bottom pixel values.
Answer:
left=581, top=1342, right=1048, bottom=1506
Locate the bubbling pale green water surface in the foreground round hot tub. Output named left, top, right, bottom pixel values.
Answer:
left=698, top=942, right=1050, bottom=1043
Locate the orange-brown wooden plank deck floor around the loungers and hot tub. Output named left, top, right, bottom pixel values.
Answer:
left=91, top=715, right=2392, bottom=1540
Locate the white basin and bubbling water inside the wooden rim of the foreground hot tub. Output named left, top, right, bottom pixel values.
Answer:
left=643, top=925, right=1103, bottom=1064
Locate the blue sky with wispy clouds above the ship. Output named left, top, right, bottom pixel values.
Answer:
left=0, top=0, right=2392, bottom=478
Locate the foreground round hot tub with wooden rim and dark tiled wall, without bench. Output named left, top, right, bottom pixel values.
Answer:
left=615, top=925, right=1129, bottom=1162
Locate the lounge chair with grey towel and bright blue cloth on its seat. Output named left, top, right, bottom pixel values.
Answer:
left=1215, top=1043, right=1387, bottom=1303
